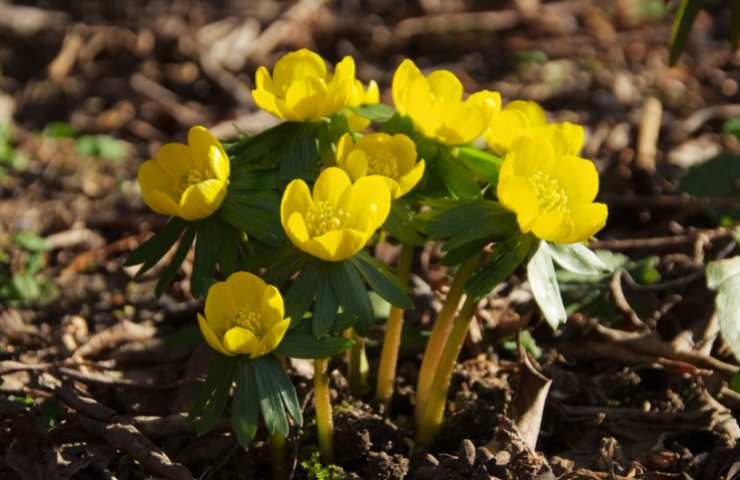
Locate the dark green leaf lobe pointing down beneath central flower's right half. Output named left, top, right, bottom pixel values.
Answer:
left=329, top=262, right=375, bottom=335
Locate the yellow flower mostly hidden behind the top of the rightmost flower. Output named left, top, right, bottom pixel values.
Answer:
left=485, top=100, right=584, bottom=156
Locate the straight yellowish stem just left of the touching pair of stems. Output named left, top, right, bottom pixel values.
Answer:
left=375, top=245, right=414, bottom=412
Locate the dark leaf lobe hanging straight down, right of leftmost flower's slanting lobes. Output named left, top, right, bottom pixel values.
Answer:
left=190, top=217, right=226, bottom=298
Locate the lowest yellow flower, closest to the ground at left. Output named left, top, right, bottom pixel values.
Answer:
left=198, top=272, right=290, bottom=358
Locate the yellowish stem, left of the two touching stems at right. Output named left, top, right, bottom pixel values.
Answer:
left=414, top=256, right=478, bottom=423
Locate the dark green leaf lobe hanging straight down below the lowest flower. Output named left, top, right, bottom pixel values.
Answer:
left=231, top=358, right=259, bottom=448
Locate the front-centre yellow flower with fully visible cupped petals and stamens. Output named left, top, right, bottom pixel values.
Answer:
left=280, top=167, right=391, bottom=262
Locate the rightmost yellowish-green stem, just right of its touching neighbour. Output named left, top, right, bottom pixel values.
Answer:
left=416, top=297, right=478, bottom=446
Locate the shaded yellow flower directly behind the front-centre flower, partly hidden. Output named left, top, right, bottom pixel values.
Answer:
left=337, top=133, right=425, bottom=199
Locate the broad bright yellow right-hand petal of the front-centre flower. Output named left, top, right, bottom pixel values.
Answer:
left=340, top=175, right=391, bottom=232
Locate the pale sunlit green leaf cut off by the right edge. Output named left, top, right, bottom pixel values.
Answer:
left=706, top=257, right=740, bottom=360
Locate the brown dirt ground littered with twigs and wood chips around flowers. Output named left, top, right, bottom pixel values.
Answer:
left=0, top=0, right=740, bottom=480
